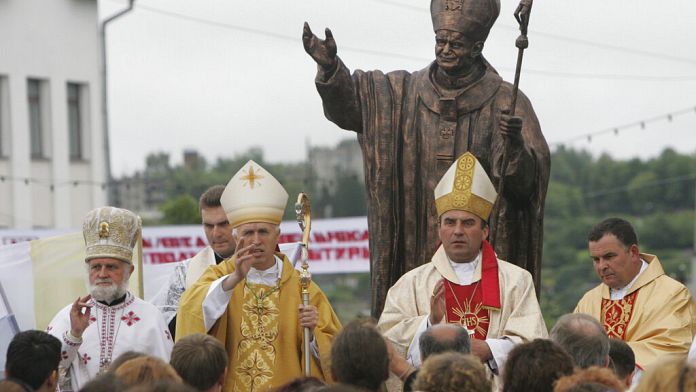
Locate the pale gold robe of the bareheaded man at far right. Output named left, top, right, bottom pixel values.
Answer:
left=574, top=253, right=696, bottom=368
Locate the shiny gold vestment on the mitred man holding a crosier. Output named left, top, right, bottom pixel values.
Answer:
left=176, top=253, right=341, bottom=392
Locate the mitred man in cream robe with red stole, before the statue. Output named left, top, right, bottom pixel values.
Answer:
left=378, top=152, right=547, bottom=388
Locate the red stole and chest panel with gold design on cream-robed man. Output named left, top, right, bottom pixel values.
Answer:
left=445, top=241, right=500, bottom=340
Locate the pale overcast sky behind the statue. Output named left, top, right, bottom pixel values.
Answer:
left=99, top=0, right=696, bottom=176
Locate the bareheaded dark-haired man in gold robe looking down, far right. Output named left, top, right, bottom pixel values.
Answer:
left=575, top=218, right=696, bottom=368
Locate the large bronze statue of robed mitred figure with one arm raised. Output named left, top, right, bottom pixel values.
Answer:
left=302, top=0, right=550, bottom=317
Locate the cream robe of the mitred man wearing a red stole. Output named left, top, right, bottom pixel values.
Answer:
left=377, top=246, right=548, bottom=353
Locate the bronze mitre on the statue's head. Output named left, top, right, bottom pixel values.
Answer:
left=430, top=0, right=500, bottom=41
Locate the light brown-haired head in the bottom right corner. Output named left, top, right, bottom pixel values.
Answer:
left=635, top=358, right=696, bottom=392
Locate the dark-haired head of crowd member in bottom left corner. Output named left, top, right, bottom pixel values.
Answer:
left=5, top=330, right=61, bottom=391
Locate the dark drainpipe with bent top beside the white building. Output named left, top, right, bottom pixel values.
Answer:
left=99, top=0, right=135, bottom=204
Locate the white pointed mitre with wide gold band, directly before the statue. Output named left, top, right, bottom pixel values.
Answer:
left=435, top=152, right=498, bottom=221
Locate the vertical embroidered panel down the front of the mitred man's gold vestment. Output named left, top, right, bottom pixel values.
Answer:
left=234, top=285, right=280, bottom=392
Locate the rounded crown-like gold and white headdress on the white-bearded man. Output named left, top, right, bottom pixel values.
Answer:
left=82, top=207, right=141, bottom=264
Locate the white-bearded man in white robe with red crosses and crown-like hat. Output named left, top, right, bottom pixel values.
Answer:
left=47, top=207, right=173, bottom=391
